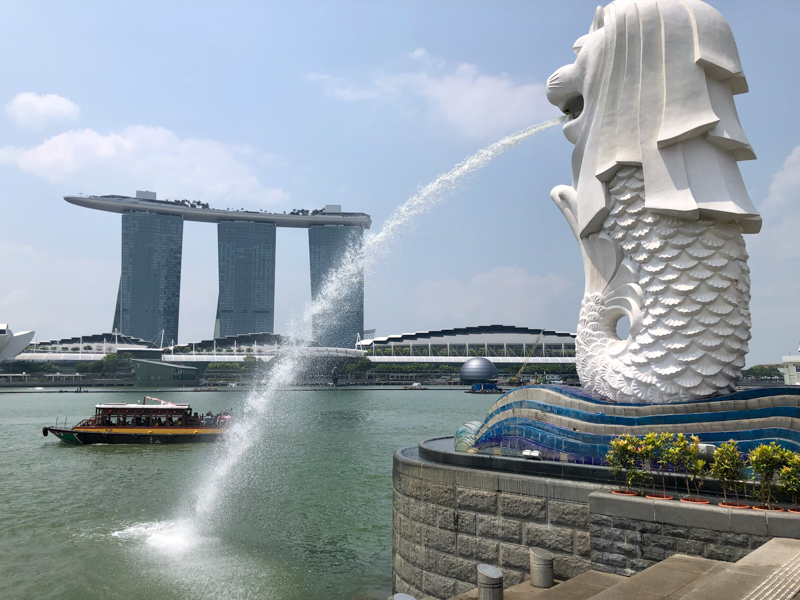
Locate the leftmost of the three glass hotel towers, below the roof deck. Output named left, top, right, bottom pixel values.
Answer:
left=114, top=212, right=183, bottom=344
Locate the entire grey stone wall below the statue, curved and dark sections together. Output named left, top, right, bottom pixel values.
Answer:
left=393, top=448, right=800, bottom=599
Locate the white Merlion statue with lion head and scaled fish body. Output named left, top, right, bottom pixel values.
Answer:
left=547, top=0, right=761, bottom=403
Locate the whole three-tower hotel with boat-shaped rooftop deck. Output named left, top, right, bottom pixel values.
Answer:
left=64, top=192, right=372, bottom=348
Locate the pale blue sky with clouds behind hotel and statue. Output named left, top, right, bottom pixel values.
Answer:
left=0, top=0, right=800, bottom=365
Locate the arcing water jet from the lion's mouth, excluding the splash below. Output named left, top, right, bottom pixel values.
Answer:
left=194, top=117, right=564, bottom=517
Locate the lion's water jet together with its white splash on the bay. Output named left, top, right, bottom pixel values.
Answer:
left=118, top=117, right=564, bottom=592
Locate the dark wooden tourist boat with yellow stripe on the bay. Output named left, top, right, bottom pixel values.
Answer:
left=42, top=396, right=231, bottom=444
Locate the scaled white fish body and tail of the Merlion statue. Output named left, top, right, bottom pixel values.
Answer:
left=556, top=167, right=751, bottom=402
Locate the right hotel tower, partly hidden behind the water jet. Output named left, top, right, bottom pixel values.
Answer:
left=308, top=225, right=364, bottom=348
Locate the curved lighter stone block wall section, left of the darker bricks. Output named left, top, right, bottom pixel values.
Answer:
left=393, top=449, right=602, bottom=598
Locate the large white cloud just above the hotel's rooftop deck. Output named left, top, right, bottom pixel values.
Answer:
left=0, top=125, right=289, bottom=208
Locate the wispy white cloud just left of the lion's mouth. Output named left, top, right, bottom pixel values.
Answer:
left=306, top=53, right=555, bottom=139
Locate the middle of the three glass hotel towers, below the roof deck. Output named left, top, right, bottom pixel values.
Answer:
left=214, top=221, right=275, bottom=338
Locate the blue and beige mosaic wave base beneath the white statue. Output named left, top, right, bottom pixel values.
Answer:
left=455, top=385, right=800, bottom=465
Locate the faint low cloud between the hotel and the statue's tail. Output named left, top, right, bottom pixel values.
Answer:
left=413, top=266, right=573, bottom=326
